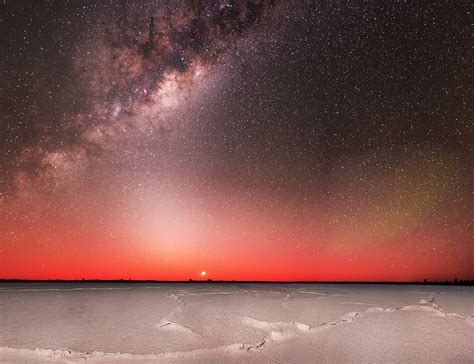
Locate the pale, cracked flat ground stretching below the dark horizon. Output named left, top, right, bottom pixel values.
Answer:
left=0, top=283, right=474, bottom=363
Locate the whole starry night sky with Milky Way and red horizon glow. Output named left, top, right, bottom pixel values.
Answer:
left=0, top=0, right=474, bottom=281
